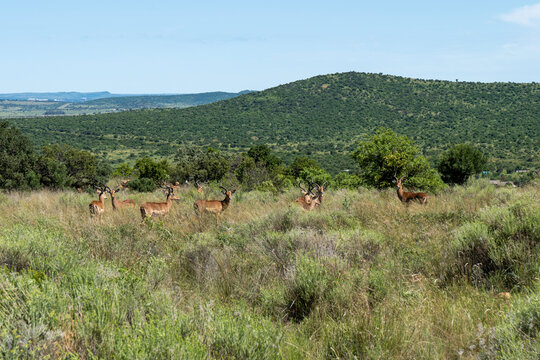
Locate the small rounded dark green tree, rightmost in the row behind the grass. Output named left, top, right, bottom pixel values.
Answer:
left=438, top=144, right=488, bottom=185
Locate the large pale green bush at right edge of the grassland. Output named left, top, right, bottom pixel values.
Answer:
left=452, top=199, right=540, bottom=289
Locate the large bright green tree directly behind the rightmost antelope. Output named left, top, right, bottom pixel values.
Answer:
left=352, top=129, right=444, bottom=190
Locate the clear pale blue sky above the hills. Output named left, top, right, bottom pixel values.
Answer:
left=0, top=0, right=540, bottom=93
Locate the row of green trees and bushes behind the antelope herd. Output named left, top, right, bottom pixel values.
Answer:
left=6, top=122, right=534, bottom=193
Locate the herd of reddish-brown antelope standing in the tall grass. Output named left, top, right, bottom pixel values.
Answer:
left=90, top=175, right=428, bottom=222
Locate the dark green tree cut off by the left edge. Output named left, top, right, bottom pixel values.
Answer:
left=0, top=121, right=39, bottom=190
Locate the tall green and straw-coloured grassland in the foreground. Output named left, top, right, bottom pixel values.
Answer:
left=0, top=182, right=540, bottom=359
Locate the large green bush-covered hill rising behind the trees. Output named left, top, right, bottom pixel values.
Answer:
left=9, top=72, right=540, bottom=171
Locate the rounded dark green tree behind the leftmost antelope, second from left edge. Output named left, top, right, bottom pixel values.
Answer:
left=38, top=144, right=111, bottom=188
